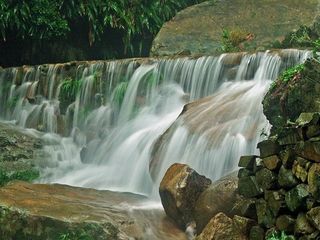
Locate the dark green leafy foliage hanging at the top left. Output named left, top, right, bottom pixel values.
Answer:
left=0, top=0, right=203, bottom=53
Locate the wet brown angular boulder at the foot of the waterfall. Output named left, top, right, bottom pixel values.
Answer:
left=159, top=163, right=211, bottom=228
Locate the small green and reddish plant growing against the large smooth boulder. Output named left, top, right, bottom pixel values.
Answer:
left=221, top=29, right=248, bottom=52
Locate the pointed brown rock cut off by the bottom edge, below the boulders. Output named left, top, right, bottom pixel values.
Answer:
left=195, top=213, right=247, bottom=240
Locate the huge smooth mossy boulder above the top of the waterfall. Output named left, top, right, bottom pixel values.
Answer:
left=151, top=0, right=318, bottom=56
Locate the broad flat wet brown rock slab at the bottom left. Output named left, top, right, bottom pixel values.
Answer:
left=0, top=182, right=185, bottom=240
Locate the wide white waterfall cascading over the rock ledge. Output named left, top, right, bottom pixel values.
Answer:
left=0, top=50, right=310, bottom=195
